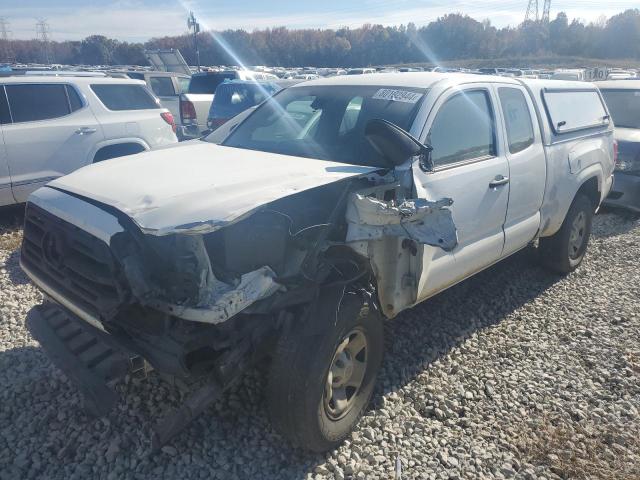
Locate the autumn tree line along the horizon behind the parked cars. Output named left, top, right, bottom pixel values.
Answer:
left=0, top=9, right=640, bottom=67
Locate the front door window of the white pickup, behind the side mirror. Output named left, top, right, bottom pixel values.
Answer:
left=427, top=90, right=496, bottom=166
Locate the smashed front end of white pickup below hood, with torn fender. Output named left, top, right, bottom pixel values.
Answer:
left=21, top=163, right=457, bottom=446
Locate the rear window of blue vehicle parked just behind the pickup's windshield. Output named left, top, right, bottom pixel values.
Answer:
left=209, top=83, right=280, bottom=118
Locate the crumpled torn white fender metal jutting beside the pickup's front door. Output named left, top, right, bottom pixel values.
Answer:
left=346, top=193, right=458, bottom=252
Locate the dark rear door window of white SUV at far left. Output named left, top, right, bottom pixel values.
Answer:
left=5, top=84, right=71, bottom=123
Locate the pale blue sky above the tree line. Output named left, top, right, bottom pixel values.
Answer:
left=5, top=0, right=639, bottom=41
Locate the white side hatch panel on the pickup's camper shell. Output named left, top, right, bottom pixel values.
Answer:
left=542, top=89, right=610, bottom=134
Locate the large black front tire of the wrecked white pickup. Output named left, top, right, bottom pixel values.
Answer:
left=267, top=286, right=384, bottom=452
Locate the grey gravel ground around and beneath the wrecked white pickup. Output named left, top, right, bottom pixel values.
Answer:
left=0, top=204, right=640, bottom=479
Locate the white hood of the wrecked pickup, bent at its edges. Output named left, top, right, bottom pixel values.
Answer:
left=48, top=142, right=378, bottom=235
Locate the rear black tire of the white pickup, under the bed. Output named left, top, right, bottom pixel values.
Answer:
left=539, top=193, right=595, bottom=275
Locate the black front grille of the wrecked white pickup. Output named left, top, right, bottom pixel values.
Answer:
left=21, top=203, right=126, bottom=320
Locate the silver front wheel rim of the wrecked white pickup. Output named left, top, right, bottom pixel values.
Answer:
left=323, top=328, right=369, bottom=420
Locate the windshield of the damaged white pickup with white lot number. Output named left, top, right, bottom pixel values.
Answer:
left=223, top=85, right=426, bottom=166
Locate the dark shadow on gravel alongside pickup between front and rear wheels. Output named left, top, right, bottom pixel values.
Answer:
left=373, top=248, right=562, bottom=406
